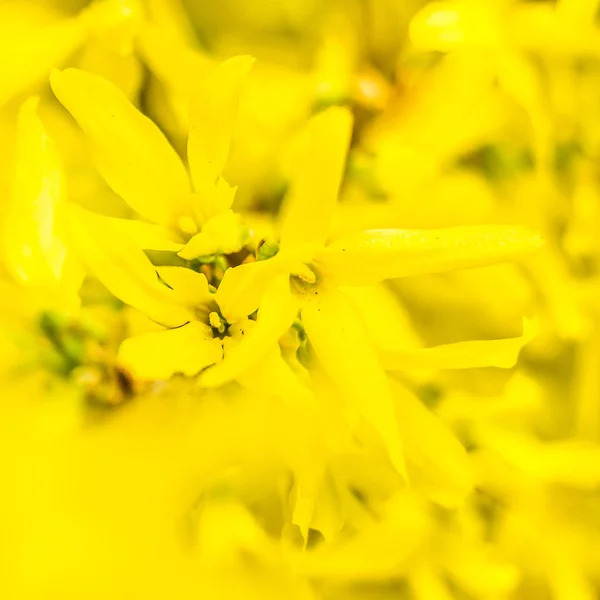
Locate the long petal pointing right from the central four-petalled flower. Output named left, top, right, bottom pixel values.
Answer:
left=315, top=225, right=542, bottom=285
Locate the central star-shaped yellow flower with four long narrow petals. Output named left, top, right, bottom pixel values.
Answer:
left=200, top=108, right=540, bottom=478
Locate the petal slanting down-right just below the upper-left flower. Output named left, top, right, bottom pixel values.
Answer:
left=69, top=206, right=193, bottom=326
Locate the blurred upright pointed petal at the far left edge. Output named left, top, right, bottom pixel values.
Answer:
left=2, top=98, right=67, bottom=284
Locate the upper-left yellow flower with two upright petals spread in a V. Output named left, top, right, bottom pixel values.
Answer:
left=51, top=57, right=253, bottom=259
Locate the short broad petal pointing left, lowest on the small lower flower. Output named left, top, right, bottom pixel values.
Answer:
left=119, top=321, right=222, bottom=380
